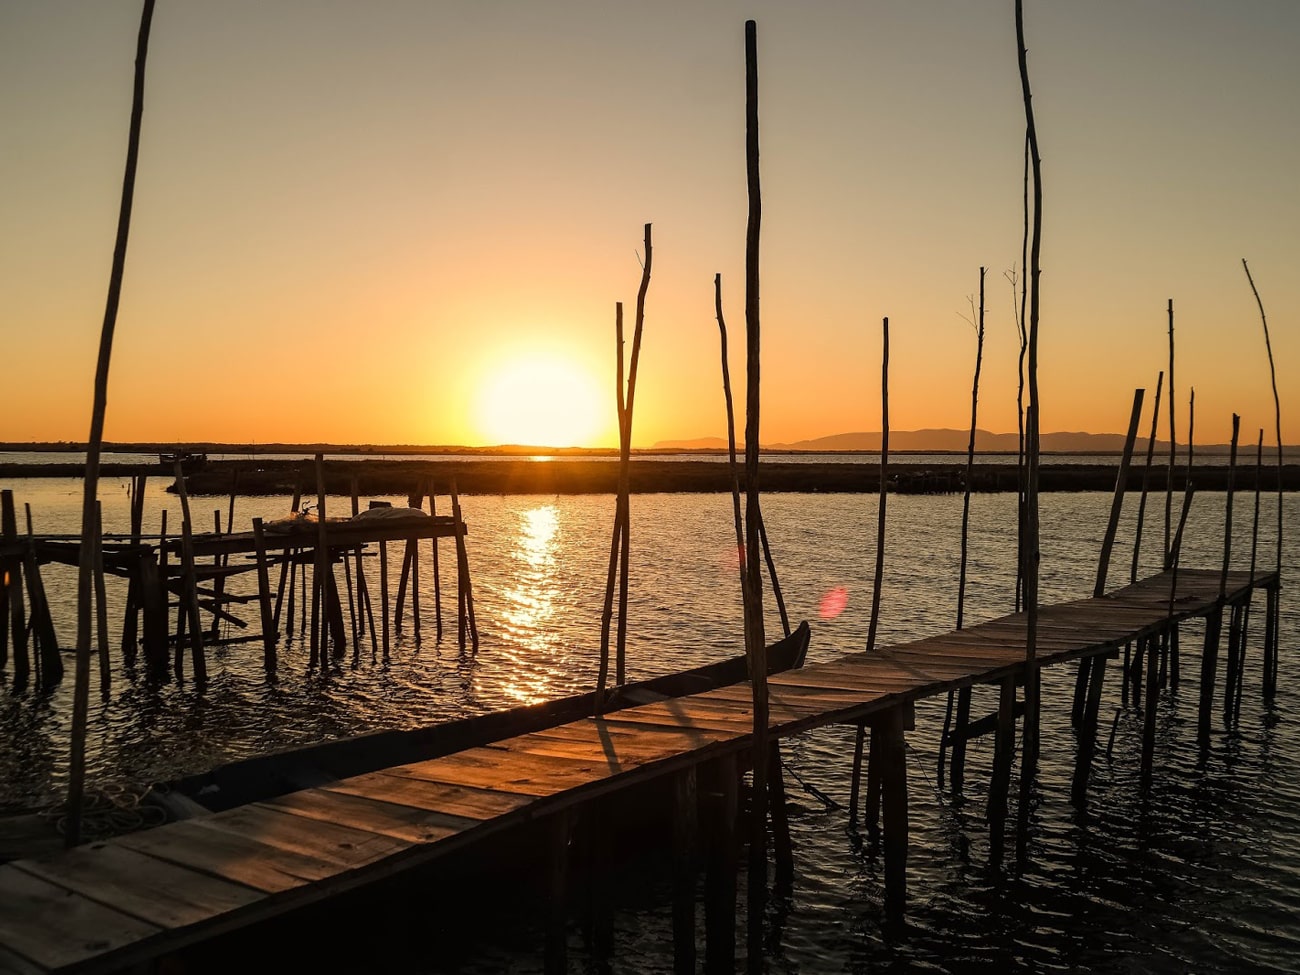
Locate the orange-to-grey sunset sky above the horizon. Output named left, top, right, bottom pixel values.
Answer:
left=0, top=0, right=1300, bottom=446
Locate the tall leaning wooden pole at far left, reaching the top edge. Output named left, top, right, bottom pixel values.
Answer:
left=64, top=0, right=153, bottom=846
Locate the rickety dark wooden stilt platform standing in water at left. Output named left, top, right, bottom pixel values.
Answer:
left=0, top=471, right=478, bottom=688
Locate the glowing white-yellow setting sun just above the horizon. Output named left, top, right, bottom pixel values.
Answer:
left=475, top=356, right=615, bottom=447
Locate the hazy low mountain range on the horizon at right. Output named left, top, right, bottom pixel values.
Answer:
left=654, top=429, right=1263, bottom=455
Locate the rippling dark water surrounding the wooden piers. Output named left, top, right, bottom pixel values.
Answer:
left=0, top=480, right=1300, bottom=975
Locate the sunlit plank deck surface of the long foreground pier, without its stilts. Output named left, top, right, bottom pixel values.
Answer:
left=0, top=569, right=1277, bottom=972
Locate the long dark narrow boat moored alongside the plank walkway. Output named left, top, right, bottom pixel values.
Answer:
left=148, top=621, right=811, bottom=819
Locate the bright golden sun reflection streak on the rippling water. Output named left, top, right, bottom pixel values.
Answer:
left=502, top=504, right=566, bottom=705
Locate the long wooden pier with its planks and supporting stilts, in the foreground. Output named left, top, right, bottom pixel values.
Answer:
left=0, top=568, right=1279, bottom=972
